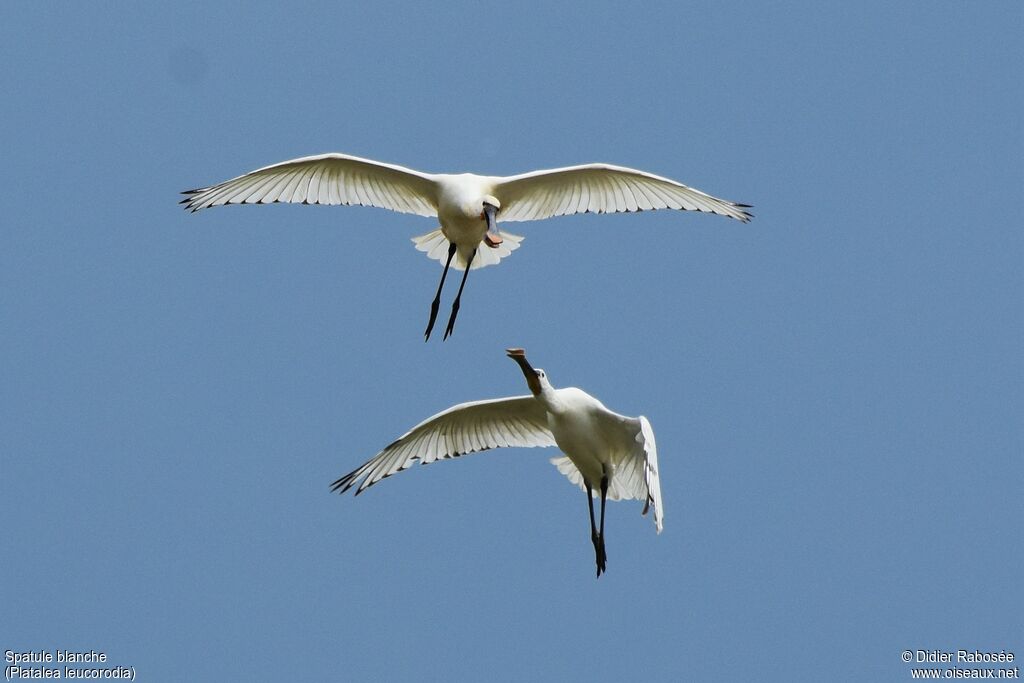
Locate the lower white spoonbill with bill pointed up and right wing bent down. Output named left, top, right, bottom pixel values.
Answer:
left=331, top=348, right=663, bottom=577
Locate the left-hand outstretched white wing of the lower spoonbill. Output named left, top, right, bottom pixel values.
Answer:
left=331, top=396, right=555, bottom=495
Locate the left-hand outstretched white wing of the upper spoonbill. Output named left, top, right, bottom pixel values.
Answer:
left=181, top=154, right=437, bottom=216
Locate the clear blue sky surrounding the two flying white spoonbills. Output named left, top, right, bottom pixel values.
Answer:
left=0, top=2, right=1024, bottom=681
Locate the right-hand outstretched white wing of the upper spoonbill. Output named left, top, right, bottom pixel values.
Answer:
left=495, top=164, right=752, bottom=222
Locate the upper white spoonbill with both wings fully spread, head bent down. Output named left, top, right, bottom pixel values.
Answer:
left=181, top=154, right=752, bottom=340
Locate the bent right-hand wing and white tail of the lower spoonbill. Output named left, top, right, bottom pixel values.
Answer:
left=551, top=415, right=663, bottom=533
